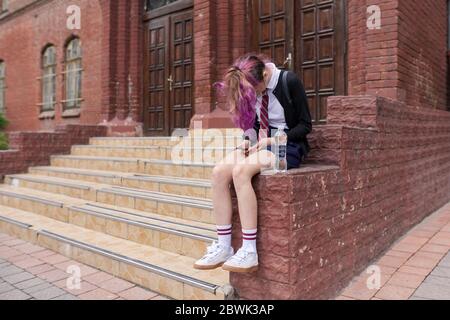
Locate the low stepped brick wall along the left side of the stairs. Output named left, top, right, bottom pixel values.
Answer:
left=0, top=125, right=107, bottom=179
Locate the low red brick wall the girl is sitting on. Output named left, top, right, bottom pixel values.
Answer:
left=231, top=96, right=450, bottom=299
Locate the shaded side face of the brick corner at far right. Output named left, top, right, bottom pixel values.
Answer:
left=398, top=0, right=449, bottom=110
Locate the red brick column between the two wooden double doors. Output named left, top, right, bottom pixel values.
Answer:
left=192, top=0, right=246, bottom=128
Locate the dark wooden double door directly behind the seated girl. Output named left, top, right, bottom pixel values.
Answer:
left=248, top=0, right=347, bottom=124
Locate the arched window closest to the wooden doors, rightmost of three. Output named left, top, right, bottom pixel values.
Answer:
left=63, top=38, right=83, bottom=110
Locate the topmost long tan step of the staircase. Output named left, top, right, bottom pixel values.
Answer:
left=89, top=134, right=243, bottom=148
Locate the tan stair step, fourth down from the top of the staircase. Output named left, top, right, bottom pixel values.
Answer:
left=28, top=166, right=211, bottom=199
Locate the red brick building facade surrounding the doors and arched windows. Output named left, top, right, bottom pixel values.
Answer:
left=0, top=0, right=448, bottom=131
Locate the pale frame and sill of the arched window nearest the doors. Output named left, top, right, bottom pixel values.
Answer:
left=61, top=37, right=84, bottom=111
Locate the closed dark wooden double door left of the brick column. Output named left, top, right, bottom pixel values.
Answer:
left=144, top=10, right=193, bottom=136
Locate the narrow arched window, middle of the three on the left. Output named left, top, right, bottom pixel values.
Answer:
left=41, top=46, right=56, bottom=112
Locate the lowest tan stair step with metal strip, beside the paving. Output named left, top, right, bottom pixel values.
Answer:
left=0, top=205, right=232, bottom=300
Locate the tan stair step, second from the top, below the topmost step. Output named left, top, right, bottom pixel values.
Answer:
left=71, top=145, right=234, bottom=163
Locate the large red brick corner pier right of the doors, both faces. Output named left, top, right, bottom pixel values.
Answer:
left=348, top=0, right=448, bottom=109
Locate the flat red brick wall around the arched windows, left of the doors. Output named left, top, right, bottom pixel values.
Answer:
left=0, top=0, right=103, bottom=131
